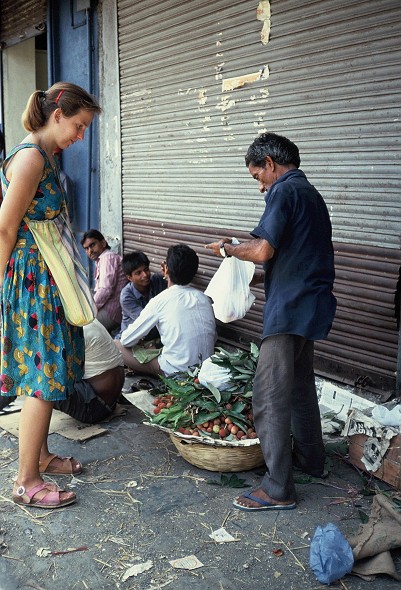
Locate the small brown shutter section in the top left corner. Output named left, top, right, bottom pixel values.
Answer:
left=0, top=0, right=47, bottom=49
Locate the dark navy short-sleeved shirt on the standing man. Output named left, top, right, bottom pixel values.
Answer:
left=251, top=169, right=336, bottom=340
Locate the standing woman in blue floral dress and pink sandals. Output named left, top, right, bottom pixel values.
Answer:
left=0, top=82, right=100, bottom=508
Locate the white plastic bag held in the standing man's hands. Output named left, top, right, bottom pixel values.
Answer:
left=205, top=238, right=255, bottom=324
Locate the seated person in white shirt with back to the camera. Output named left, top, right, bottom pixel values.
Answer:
left=114, top=244, right=216, bottom=375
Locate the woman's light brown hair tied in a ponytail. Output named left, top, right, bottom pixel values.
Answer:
left=21, top=82, right=101, bottom=131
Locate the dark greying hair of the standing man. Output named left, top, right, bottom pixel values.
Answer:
left=245, top=133, right=301, bottom=168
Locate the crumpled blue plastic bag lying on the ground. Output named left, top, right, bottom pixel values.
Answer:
left=309, top=522, right=354, bottom=584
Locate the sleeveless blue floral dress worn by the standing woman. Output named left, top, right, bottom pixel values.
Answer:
left=0, top=143, right=85, bottom=401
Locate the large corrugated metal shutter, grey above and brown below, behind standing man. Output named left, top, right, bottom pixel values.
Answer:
left=118, top=0, right=401, bottom=400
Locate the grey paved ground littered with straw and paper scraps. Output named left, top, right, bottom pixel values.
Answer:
left=0, top=394, right=401, bottom=590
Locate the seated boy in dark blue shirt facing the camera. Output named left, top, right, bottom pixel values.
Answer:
left=116, top=251, right=167, bottom=340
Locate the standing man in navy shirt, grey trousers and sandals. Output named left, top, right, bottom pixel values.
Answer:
left=206, top=133, right=336, bottom=511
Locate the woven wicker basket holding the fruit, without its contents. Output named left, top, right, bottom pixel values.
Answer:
left=170, top=434, right=264, bottom=472
